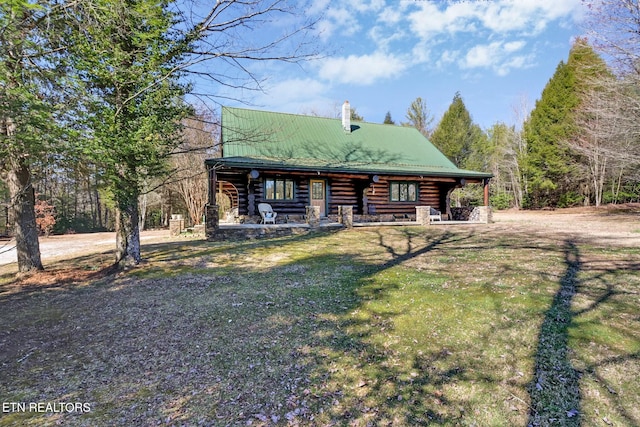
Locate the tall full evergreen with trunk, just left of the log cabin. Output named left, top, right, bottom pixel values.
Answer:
left=68, top=0, right=189, bottom=267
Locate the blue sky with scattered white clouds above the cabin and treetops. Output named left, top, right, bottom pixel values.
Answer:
left=211, top=0, right=585, bottom=129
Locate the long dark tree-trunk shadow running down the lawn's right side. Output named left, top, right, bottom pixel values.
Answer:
left=527, top=240, right=582, bottom=426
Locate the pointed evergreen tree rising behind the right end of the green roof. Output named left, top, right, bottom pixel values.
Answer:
left=431, top=92, right=486, bottom=169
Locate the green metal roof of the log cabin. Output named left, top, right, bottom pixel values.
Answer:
left=212, top=107, right=491, bottom=178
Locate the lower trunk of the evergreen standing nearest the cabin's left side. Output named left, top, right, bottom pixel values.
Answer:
left=116, top=194, right=141, bottom=269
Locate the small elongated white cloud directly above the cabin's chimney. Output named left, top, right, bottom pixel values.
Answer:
left=320, top=52, right=411, bottom=86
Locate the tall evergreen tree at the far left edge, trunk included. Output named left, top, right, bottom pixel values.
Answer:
left=0, top=0, right=64, bottom=272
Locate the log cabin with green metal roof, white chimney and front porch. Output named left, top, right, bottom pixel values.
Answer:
left=205, top=101, right=491, bottom=226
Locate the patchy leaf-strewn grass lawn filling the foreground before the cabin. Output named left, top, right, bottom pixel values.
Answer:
left=0, top=226, right=640, bottom=426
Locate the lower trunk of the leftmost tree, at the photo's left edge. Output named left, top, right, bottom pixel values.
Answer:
left=7, top=160, right=44, bottom=273
